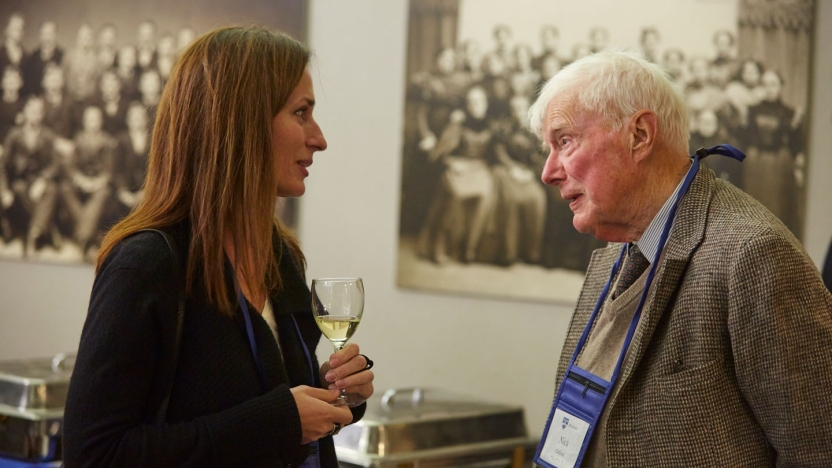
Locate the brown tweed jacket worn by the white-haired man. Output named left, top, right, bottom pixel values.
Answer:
left=555, top=167, right=832, bottom=468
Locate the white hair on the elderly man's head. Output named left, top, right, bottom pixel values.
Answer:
left=529, top=50, right=690, bottom=154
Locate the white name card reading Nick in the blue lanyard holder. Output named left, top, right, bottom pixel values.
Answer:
left=540, top=408, right=589, bottom=468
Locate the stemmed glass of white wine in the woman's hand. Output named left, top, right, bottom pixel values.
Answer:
left=312, top=278, right=364, bottom=406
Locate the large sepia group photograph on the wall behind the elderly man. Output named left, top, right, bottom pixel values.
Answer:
left=397, top=0, right=815, bottom=303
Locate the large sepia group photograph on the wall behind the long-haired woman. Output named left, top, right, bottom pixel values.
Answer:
left=0, top=0, right=307, bottom=263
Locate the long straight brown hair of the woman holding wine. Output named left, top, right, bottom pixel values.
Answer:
left=96, top=27, right=310, bottom=314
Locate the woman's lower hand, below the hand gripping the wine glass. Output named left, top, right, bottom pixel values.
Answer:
left=292, top=385, right=352, bottom=444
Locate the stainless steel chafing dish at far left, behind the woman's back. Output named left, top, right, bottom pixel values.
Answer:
left=0, top=354, right=74, bottom=461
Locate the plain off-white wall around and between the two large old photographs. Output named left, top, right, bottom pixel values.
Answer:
left=0, top=0, right=832, bottom=434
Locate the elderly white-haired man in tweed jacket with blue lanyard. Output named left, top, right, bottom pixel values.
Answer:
left=529, top=52, right=832, bottom=468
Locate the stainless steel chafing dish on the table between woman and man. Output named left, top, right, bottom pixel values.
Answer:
left=335, top=388, right=538, bottom=468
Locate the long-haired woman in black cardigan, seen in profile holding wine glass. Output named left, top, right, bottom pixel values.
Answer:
left=64, top=28, right=373, bottom=468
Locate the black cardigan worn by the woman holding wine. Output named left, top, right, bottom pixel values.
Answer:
left=64, top=222, right=366, bottom=468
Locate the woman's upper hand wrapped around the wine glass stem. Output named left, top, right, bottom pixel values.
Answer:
left=321, top=343, right=374, bottom=403
